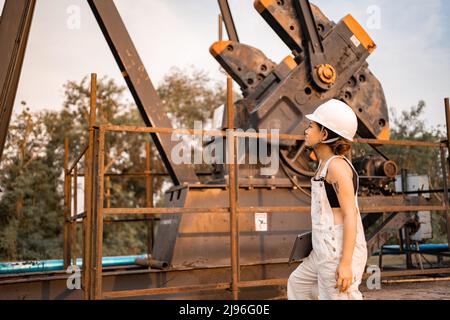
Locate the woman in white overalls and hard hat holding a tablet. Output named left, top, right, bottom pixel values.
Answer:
left=287, top=99, right=367, bottom=300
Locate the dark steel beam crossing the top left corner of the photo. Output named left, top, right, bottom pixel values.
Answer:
left=0, top=0, right=36, bottom=160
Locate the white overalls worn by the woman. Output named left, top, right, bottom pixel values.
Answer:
left=287, top=156, right=367, bottom=300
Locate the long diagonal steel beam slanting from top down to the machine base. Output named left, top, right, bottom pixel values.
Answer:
left=88, top=0, right=199, bottom=185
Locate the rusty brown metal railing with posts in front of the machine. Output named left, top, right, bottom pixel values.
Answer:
left=57, top=75, right=450, bottom=300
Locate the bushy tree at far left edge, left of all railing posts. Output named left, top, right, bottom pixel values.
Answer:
left=0, top=106, right=62, bottom=260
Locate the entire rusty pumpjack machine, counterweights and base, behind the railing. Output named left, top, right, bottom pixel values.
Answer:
left=153, top=0, right=403, bottom=266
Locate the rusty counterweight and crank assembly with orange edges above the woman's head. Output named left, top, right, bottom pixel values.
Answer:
left=210, top=0, right=389, bottom=181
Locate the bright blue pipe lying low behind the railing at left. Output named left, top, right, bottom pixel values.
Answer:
left=0, top=254, right=147, bottom=275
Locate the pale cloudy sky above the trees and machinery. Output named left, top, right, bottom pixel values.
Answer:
left=0, top=0, right=450, bottom=131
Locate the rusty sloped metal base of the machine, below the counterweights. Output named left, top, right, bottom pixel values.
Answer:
left=153, top=187, right=311, bottom=267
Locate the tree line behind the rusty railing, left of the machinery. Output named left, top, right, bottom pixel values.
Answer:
left=0, top=69, right=225, bottom=260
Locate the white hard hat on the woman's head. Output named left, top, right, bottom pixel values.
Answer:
left=305, top=99, right=358, bottom=143
